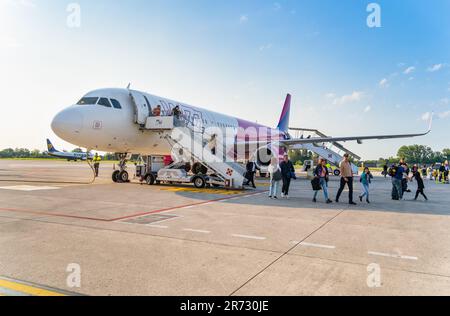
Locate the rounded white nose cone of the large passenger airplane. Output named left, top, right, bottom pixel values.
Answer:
left=51, top=108, right=83, bottom=141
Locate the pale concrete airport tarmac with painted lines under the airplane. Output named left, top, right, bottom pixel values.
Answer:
left=0, top=160, right=450, bottom=296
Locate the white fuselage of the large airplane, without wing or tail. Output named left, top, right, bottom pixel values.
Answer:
left=52, top=89, right=284, bottom=155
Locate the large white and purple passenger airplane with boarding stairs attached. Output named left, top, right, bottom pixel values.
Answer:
left=51, top=85, right=431, bottom=180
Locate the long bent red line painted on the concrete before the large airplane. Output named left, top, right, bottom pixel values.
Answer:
left=0, top=192, right=261, bottom=222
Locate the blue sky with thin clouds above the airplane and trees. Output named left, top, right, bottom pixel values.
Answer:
left=0, top=0, right=450, bottom=159
